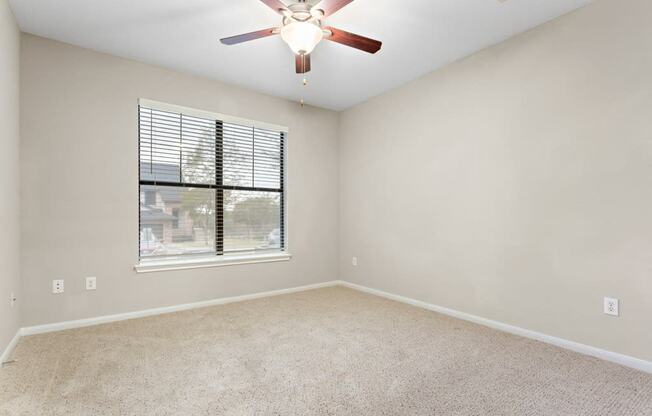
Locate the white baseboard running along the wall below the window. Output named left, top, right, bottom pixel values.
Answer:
left=21, top=280, right=340, bottom=335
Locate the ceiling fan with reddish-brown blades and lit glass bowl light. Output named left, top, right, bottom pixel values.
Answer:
left=220, top=0, right=382, bottom=74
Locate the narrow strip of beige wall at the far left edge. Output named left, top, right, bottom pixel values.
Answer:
left=0, top=0, right=23, bottom=354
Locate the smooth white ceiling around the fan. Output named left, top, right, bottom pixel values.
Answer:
left=11, top=0, right=591, bottom=110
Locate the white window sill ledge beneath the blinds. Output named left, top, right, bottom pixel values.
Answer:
left=134, top=252, right=292, bottom=273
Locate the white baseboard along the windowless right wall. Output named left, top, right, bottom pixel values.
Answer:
left=339, top=280, right=652, bottom=373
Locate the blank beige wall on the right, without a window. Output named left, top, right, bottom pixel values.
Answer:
left=340, top=0, right=652, bottom=360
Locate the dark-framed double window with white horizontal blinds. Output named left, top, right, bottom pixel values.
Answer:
left=138, top=100, right=287, bottom=264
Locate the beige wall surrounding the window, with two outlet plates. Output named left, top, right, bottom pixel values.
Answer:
left=21, top=35, right=338, bottom=326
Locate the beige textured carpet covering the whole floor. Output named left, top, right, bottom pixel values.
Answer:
left=0, top=287, right=652, bottom=416
